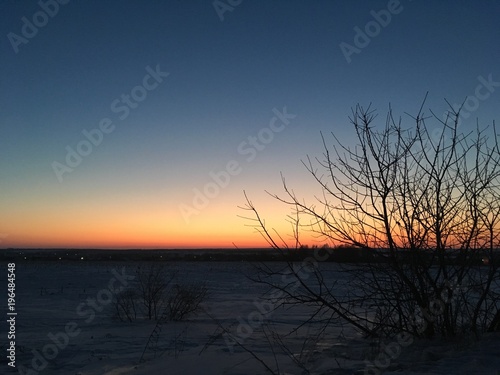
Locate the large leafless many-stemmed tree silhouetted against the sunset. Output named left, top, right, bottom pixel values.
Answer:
left=242, top=100, right=500, bottom=344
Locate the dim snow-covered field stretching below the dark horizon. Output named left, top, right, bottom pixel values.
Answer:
left=0, top=261, right=500, bottom=375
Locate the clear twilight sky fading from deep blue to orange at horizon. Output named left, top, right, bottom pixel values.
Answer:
left=0, top=0, right=500, bottom=248
